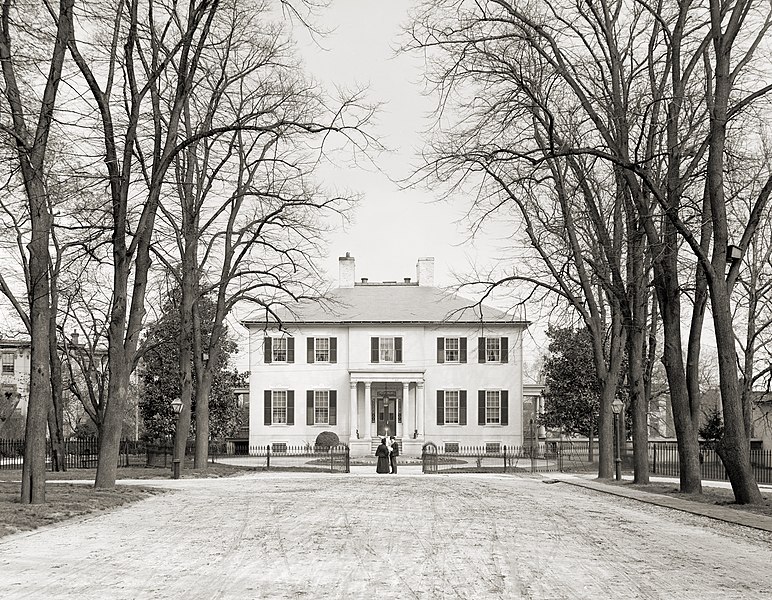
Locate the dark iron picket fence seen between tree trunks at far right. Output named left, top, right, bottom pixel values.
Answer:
left=648, top=442, right=772, bottom=483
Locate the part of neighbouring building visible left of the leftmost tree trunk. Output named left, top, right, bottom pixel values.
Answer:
left=0, top=340, right=30, bottom=438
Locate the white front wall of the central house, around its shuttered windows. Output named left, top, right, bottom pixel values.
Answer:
left=249, top=325, right=523, bottom=454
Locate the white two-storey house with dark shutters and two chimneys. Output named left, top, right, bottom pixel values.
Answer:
left=243, top=254, right=527, bottom=456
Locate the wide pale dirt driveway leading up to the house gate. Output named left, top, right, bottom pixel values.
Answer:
left=0, top=468, right=772, bottom=600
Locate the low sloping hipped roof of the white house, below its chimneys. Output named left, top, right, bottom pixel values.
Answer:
left=242, top=283, right=528, bottom=327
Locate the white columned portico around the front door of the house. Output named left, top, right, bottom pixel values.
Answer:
left=349, top=370, right=425, bottom=456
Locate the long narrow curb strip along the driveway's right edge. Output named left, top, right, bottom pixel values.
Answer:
left=545, top=475, right=772, bottom=533
